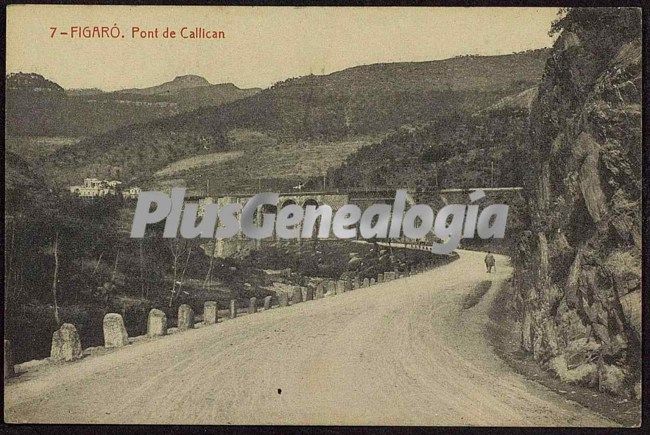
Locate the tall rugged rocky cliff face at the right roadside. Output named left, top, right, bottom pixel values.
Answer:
left=513, top=8, right=642, bottom=397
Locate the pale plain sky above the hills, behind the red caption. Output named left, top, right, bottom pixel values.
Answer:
left=6, top=5, right=558, bottom=91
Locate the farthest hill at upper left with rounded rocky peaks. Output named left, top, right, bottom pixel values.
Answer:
left=5, top=73, right=258, bottom=137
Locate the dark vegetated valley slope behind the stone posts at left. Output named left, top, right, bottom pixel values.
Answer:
left=5, top=153, right=254, bottom=361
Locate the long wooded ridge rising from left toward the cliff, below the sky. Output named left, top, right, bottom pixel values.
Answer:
left=44, top=49, right=548, bottom=186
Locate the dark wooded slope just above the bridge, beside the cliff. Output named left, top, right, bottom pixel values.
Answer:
left=322, top=88, right=536, bottom=190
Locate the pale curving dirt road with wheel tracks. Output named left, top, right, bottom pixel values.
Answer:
left=5, top=251, right=614, bottom=426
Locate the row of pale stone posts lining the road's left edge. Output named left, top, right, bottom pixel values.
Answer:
left=4, top=262, right=433, bottom=379
